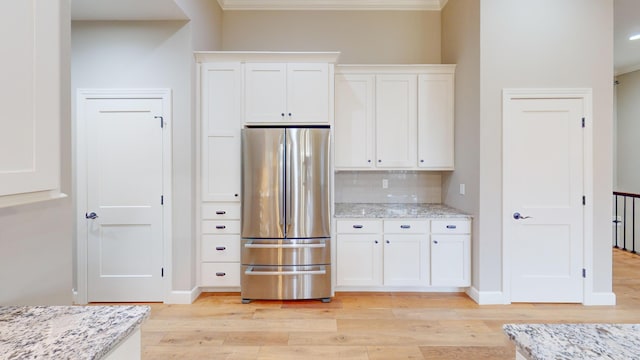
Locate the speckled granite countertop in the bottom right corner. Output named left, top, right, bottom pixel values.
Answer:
left=504, top=324, right=640, bottom=360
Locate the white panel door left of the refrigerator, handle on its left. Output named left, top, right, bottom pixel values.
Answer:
left=85, top=99, right=163, bottom=302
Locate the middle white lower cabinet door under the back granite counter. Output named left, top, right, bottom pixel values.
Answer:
left=383, top=234, right=428, bottom=286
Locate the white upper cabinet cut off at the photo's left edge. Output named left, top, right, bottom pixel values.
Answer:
left=0, top=0, right=65, bottom=207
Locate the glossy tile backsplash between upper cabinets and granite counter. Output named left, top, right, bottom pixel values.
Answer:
left=335, top=170, right=442, bottom=204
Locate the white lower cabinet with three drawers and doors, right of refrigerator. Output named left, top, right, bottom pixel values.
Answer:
left=336, top=219, right=471, bottom=290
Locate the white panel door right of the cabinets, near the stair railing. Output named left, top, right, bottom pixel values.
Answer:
left=503, top=96, right=584, bottom=302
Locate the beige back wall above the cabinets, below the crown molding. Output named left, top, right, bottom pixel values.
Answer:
left=222, top=11, right=441, bottom=64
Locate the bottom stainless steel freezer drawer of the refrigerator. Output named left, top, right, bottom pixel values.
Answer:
left=241, top=265, right=331, bottom=301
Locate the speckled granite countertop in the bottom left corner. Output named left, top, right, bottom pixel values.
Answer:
left=0, top=306, right=151, bottom=360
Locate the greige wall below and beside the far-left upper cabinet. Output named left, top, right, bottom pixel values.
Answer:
left=0, top=0, right=74, bottom=305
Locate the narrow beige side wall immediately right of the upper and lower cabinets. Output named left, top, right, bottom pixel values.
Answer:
left=442, top=0, right=480, bottom=287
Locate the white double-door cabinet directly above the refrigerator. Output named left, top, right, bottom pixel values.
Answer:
left=244, top=63, right=332, bottom=123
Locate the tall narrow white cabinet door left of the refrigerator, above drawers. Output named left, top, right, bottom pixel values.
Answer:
left=200, top=62, right=242, bottom=201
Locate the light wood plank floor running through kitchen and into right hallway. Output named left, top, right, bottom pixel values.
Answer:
left=142, top=251, right=640, bottom=360
